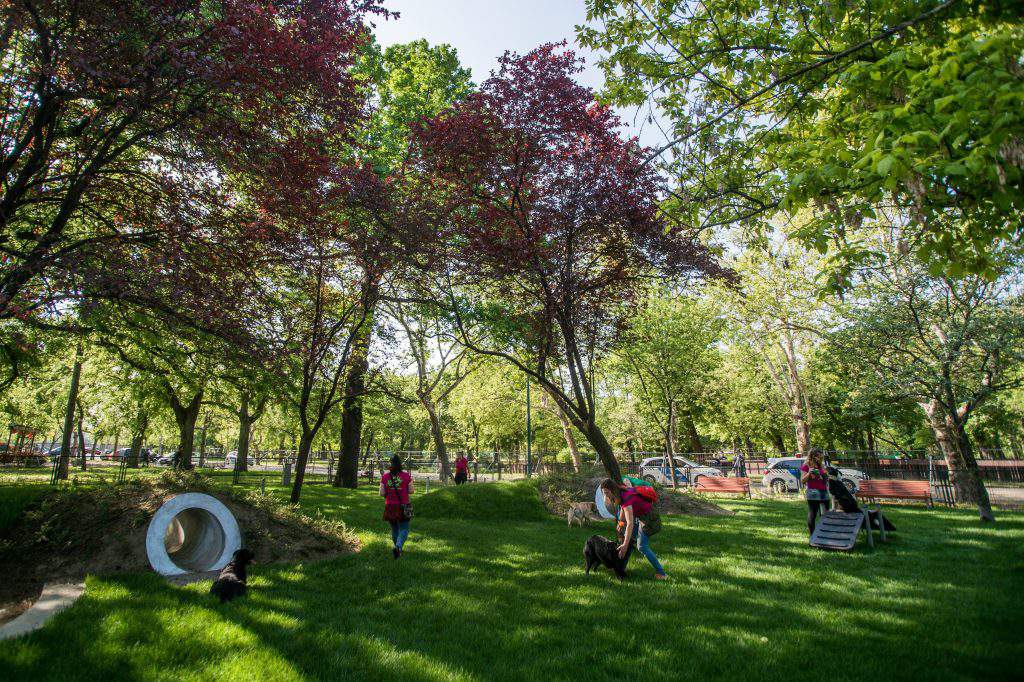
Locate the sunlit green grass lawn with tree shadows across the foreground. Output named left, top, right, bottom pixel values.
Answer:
left=0, top=473, right=1024, bottom=682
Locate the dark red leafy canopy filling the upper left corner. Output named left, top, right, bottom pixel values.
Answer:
left=0, top=0, right=382, bottom=356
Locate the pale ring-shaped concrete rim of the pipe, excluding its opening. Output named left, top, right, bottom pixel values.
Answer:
left=145, top=493, right=242, bottom=576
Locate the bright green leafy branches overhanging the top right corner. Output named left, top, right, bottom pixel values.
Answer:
left=579, top=0, right=1024, bottom=276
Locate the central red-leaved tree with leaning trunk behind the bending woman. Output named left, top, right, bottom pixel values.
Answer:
left=417, top=44, right=718, bottom=479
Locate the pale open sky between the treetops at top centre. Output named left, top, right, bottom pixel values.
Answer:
left=377, top=0, right=663, bottom=145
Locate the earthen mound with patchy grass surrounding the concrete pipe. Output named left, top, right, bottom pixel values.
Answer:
left=0, top=471, right=358, bottom=623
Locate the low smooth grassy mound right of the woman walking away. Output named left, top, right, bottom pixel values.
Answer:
left=414, top=481, right=549, bottom=521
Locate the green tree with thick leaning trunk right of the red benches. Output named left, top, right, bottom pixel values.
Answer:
left=835, top=223, right=1024, bottom=520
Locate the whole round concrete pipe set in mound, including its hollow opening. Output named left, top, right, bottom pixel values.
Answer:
left=145, top=493, right=242, bottom=576
